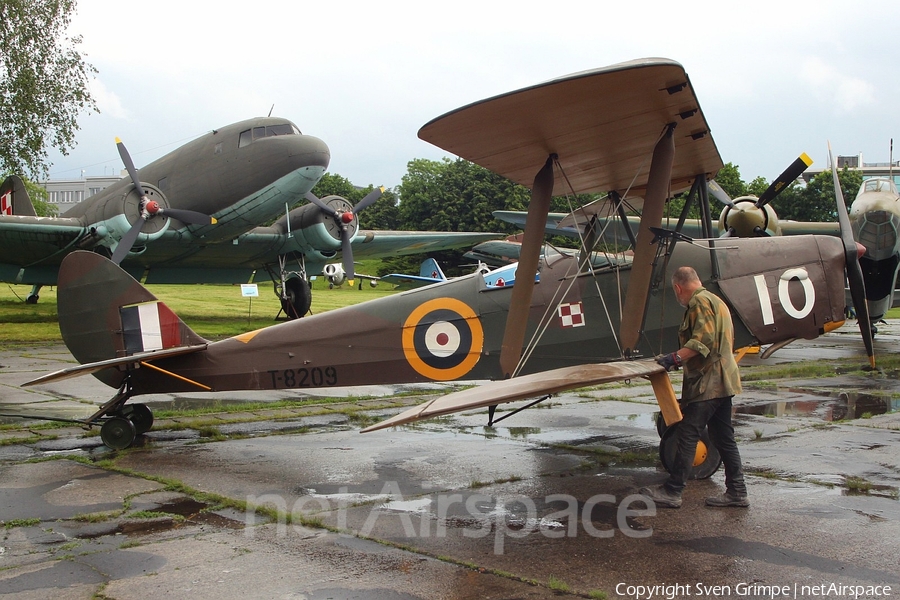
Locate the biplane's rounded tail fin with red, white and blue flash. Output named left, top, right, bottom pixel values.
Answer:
left=57, top=251, right=208, bottom=387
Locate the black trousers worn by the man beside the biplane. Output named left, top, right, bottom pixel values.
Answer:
left=666, top=396, right=747, bottom=496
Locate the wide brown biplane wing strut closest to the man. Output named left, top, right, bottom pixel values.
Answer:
left=620, top=123, right=675, bottom=356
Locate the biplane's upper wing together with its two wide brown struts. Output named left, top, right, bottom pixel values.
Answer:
left=419, top=58, right=723, bottom=376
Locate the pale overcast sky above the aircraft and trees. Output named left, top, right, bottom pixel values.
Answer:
left=50, top=0, right=900, bottom=187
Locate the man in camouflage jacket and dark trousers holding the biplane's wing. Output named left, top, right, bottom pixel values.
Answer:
left=640, top=267, right=750, bottom=508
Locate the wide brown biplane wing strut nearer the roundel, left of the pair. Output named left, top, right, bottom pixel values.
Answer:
left=500, top=154, right=558, bottom=379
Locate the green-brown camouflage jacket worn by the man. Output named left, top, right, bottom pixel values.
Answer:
left=678, top=287, right=741, bottom=403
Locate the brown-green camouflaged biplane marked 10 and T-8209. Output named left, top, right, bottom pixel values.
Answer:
left=14, top=59, right=871, bottom=474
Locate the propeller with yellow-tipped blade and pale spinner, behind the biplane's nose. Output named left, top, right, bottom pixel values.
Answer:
left=708, top=152, right=812, bottom=237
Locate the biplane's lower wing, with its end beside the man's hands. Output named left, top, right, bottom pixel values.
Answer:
left=362, top=360, right=665, bottom=433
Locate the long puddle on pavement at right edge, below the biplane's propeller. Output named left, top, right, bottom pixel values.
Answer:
left=734, top=390, right=900, bottom=421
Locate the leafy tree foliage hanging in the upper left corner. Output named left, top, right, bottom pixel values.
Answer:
left=0, top=0, right=99, bottom=179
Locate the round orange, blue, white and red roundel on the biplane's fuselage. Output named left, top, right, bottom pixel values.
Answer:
left=403, top=298, right=484, bottom=381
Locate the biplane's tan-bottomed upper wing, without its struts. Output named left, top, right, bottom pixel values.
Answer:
left=419, top=58, right=723, bottom=196
